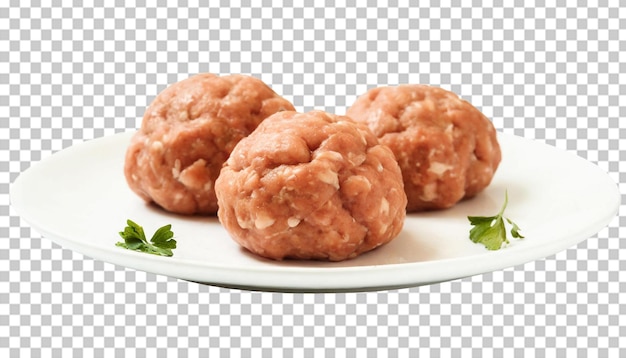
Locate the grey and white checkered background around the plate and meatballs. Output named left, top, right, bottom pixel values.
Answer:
left=0, top=0, right=626, bottom=357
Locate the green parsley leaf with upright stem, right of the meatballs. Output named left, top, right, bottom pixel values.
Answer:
left=467, top=191, right=524, bottom=250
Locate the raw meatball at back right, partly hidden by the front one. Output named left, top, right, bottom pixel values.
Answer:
left=347, top=85, right=501, bottom=212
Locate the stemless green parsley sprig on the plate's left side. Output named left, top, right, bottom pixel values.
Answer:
left=115, top=220, right=176, bottom=256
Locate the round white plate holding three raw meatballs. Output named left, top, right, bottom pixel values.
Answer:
left=11, top=133, right=620, bottom=291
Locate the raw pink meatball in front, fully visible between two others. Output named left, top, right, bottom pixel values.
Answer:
left=215, top=111, right=406, bottom=261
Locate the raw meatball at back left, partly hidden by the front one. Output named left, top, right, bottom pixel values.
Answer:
left=124, top=74, right=294, bottom=214
